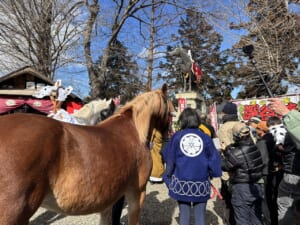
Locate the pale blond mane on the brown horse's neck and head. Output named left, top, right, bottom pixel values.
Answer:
left=113, top=87, right=169, bottom=143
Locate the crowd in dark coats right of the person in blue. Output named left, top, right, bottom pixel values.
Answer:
left=213, top=99, right=300, bottom=225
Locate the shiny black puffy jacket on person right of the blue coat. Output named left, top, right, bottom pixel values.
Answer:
left=222, top=137, right=263, bottom=183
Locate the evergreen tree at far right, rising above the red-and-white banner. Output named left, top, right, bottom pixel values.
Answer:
left=231, top=0, right=300, bottom=98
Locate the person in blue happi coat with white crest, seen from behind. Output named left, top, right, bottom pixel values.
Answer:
left=162, top=108, right=222, bottom=225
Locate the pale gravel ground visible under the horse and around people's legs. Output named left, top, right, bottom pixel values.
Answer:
left=30, top=180, right=223, bottom=225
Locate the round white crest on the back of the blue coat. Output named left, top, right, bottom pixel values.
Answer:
left=180, top=133, right=203, bottom=157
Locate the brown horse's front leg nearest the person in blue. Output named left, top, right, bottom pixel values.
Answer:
left=126, top=190, right=146, bottom=225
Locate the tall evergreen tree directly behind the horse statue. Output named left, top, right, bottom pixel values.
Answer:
left=161, top=9, right=234, bottom=103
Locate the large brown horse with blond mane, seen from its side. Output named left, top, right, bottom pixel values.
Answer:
left=0, top=85, right=171, bottom=225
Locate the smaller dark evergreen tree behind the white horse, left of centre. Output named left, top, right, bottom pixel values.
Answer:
left=94, top=40, right=142, bottom=103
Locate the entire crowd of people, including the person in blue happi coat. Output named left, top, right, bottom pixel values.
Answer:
left=111, top=98, right=300, bottom=225
